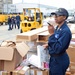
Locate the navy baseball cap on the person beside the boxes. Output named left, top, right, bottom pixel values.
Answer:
left=51, top=8, right=69, bottom=19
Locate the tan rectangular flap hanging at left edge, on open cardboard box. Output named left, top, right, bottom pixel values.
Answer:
left=0, top=47, right=14, bottom=60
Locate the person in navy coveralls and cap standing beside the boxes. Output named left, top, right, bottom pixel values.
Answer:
left=43, top=8, right=71, bottom=75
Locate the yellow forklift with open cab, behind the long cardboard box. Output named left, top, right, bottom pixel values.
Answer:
left=20, top=8, right=43, bottom=33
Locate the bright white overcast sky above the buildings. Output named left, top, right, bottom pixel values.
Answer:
left=13, top=0, right=75, bottom=9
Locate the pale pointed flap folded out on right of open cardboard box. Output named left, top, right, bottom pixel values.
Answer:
left=16, top=42, right=30, bottom=57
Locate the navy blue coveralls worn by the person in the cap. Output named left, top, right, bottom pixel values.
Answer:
left=48, top=22, right=71, bottom=75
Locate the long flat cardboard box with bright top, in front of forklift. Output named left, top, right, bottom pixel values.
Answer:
left=16, top=26, right=48, bottom=41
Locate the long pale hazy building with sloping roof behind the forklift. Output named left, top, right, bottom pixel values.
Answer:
left=4, top=3, right=57, bottom=15
